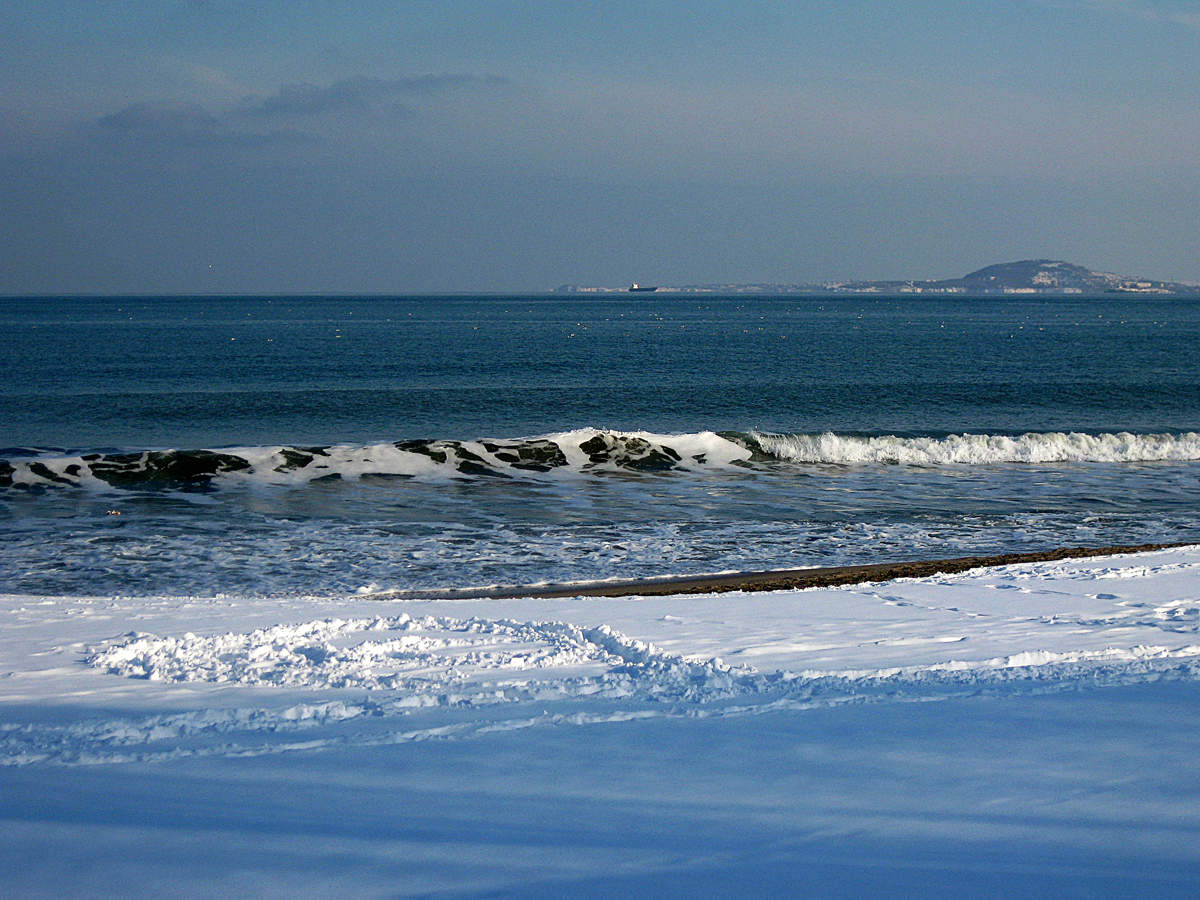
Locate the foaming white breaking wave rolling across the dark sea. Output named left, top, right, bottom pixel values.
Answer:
left=0, top=428, right=1200, bottom=491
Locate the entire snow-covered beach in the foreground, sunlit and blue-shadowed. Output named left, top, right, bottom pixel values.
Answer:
left=0, top=547, right=1200, bottom=896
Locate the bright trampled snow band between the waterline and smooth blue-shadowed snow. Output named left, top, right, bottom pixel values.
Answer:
left=0, top=548, right=1200, bottom=766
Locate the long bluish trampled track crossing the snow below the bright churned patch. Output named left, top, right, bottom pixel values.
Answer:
left=7, top=635, right=1200, bottom=766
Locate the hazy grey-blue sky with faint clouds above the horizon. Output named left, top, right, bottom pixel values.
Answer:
left=0, top=0, right=1200, bottom=294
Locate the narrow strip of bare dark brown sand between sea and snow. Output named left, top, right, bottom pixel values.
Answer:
left=372, top=541, right=1193, bottom=600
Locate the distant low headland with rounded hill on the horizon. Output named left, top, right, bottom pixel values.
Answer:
left=554, top=259, right=1200, bottom=296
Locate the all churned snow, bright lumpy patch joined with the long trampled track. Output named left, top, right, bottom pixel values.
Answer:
left=0, top=613, right=1200, bottom=766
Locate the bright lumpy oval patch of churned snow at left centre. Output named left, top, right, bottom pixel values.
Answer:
left=88, top=613, right=752, bottom=707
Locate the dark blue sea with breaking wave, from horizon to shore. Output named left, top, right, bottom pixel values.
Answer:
left=0, top=293, right=1200, bottom=596
